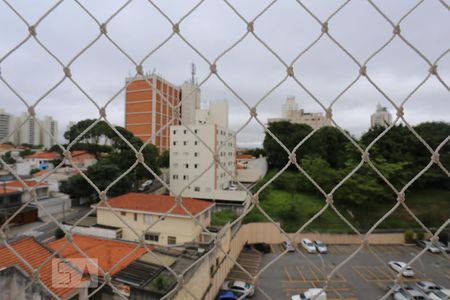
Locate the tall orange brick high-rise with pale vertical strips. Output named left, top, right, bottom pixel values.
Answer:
left=125, top=74, right=181, bottom=153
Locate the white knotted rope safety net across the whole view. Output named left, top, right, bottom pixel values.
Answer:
left=0, top=0, right=450, bottom=299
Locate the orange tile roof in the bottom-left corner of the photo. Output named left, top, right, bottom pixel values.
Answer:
left=0, top=237, right=75, bottom=298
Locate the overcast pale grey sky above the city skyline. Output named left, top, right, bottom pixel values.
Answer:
left=0, top=0, right=450, bottom=147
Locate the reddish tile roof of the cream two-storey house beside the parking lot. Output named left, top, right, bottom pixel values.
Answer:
left=99, top=193, right=214, bottom=215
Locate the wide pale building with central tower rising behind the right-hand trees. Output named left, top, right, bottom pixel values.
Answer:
left=267, top=96, right=331, bottom=129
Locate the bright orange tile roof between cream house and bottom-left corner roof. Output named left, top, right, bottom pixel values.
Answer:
left=48, top=235, right=149, bottom=276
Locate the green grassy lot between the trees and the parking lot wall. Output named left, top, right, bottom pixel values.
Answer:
left=212, top=189, right=450, bottom=233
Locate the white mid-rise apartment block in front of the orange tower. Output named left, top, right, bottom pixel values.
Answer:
left=170, top=101, right=245, bottom=201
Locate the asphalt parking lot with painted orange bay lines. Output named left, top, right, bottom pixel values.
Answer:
left=229, top=245, right=450, bottom=300
